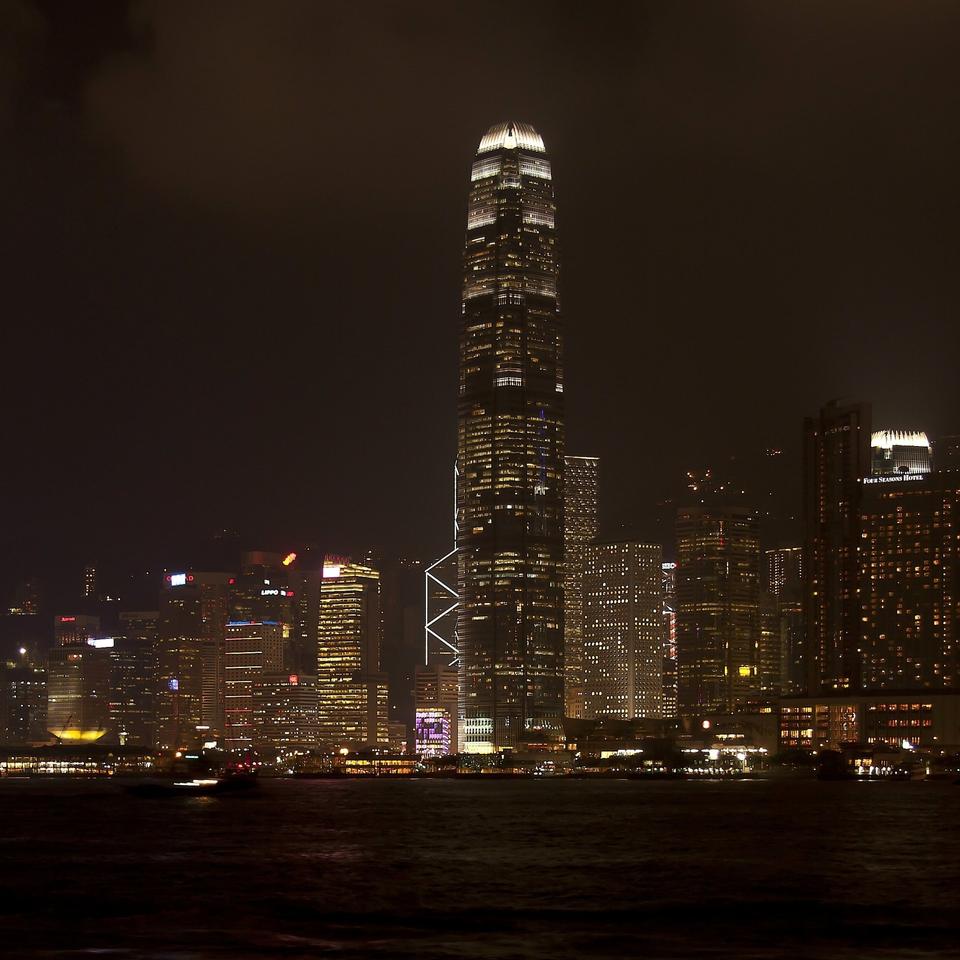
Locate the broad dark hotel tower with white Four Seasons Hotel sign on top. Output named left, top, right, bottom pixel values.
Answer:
left=860, top=470, right=960, bottom=690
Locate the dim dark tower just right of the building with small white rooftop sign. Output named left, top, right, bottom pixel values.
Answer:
left=110, top=610, right=159, bottom=747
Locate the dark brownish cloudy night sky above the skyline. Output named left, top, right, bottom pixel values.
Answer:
left=0, top=0, right=960, bottom=600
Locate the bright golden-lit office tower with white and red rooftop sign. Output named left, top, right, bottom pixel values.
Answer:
left=317, top=558, right=389, bottom=750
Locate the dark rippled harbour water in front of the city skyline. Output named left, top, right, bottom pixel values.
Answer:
left=0, top=780, right=960, bottom=960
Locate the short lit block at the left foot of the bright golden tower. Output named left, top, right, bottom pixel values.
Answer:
left=253, top=673, right=317, bottom=756
